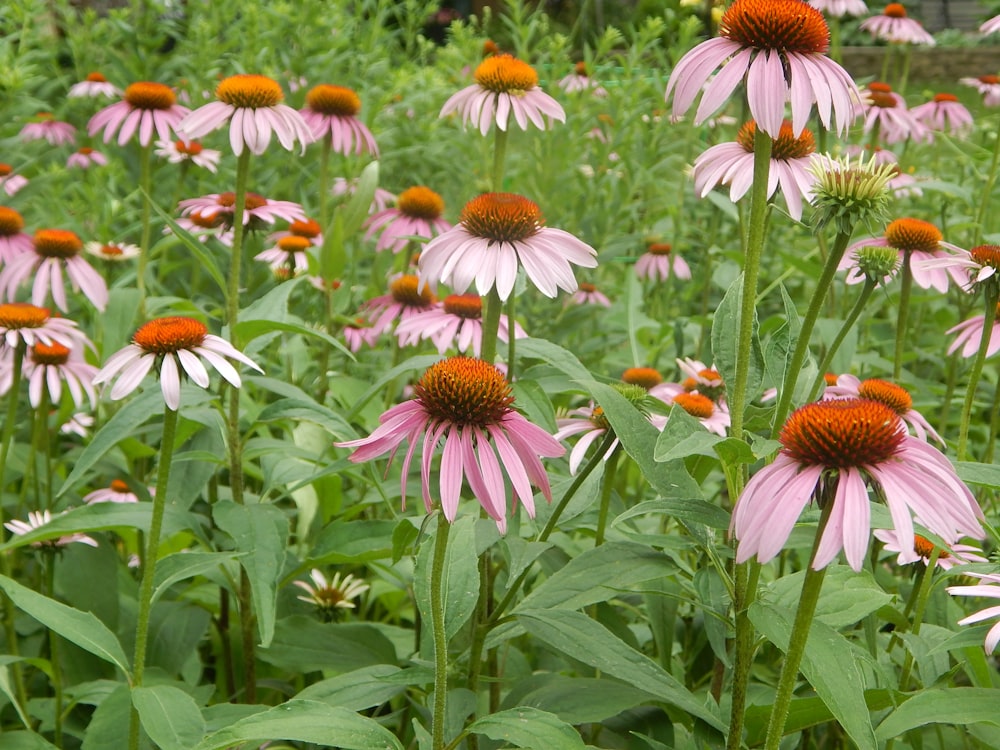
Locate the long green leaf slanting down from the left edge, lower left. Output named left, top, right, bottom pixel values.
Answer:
left=0, top=576, right=129, bottom=675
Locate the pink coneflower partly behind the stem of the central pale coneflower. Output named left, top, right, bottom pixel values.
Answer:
left=396, top=294, right=528, bottom=357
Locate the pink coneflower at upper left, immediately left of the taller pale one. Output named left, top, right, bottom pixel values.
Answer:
left=87, top=81, right=188, bottom=146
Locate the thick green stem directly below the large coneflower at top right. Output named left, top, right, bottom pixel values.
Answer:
left=727, top=128, right=772, bottom=446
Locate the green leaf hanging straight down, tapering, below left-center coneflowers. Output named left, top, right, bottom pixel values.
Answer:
left=212, top=501, right=288, bottom=646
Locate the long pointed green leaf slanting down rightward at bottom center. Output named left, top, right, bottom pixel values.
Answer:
left=517, top=609, right=725, bottom=731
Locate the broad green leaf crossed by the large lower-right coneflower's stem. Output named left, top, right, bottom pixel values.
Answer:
left=749, top=600, right=876, bottom=750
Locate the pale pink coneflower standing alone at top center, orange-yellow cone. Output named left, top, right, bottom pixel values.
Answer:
left=440, top=54, right=566, bottom=135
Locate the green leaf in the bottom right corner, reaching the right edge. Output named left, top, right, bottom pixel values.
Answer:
left=875, top=687, right=1000, bottom=742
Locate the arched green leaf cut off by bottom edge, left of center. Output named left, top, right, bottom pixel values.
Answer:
left=194, top=699, right=403, bottom=750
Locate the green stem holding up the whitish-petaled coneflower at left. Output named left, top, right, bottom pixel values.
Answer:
left=128, top=407, right=177, bottom=750
